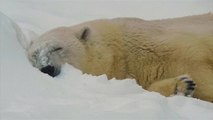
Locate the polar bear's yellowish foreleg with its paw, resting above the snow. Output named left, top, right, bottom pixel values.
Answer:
left=148, top=75, right=196, bottom=96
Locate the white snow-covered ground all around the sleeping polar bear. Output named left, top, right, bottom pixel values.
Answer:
left=0, top=0, right=213, bottom=120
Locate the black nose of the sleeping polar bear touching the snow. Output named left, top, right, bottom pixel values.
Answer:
left=40, top=65, right=61, bottom=77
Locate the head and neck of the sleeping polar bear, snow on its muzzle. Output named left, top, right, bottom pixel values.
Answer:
left=27, top=21, right=124, bottom=77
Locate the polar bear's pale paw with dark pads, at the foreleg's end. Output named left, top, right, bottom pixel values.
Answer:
left=174, top=75, right=196, bottom=97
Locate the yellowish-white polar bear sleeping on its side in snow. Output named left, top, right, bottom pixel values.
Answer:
left=27, top=13, right=213, bottom=101
